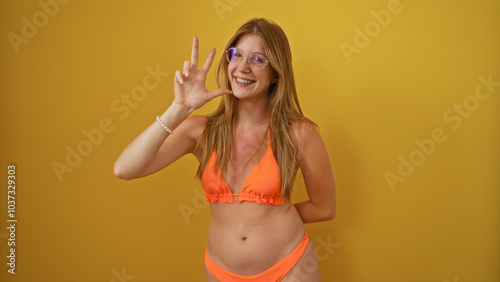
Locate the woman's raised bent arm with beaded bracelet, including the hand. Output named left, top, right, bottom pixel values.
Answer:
left=114, top=36, right=231, bottom=180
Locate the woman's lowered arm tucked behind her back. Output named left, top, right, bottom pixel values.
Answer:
left=295, top=122, right=336, bottom=223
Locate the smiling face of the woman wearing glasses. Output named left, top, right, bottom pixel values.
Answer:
left=228, top=34, right=276, bottom=99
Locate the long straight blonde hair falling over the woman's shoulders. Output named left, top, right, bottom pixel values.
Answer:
left=196, top=18, right=311, bottom=201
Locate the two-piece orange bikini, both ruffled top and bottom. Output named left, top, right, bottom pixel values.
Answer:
left=201, top=131, right=309, bottom=282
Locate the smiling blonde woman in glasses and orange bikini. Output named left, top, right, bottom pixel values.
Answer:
left=114, top=19, right=336, bottom=282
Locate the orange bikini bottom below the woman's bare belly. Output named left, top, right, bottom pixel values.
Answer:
left=205, top=232, right=309, bottom=282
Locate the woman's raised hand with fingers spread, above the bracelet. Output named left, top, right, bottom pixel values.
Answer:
left=174, top=36, right=232, bottom=110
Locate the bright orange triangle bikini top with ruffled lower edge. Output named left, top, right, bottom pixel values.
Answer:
left=201, top=131, right=285, bottom=205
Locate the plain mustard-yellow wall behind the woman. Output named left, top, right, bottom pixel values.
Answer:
left=0, top=0, right=500, bottom=282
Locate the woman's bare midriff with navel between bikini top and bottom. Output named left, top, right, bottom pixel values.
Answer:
left=204, top=199, right=305, bottom=275
